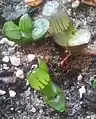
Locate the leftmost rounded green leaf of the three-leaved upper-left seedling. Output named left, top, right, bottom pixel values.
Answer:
left=3, top=21, right=21, bottom=41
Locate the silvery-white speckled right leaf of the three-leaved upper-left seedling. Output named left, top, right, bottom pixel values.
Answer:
left=32, top=19, right=49, bottom=41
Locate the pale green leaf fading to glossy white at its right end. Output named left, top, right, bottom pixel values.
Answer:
left=50, top=22, right=91, bottom=47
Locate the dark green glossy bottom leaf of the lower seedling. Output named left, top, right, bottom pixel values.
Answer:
left=42, top=81, right=66, bottom=112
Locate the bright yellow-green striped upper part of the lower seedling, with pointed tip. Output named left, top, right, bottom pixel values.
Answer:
left=28, top=59, right=50, bottom=90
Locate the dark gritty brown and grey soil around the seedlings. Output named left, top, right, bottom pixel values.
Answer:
left=0, top=0, right=96, bottom=119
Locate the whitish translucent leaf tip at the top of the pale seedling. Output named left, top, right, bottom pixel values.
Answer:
left=42, top=1, right=59, bottom=16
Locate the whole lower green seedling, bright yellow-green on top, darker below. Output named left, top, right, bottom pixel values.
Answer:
left=27, top=59, right=66, bottom=112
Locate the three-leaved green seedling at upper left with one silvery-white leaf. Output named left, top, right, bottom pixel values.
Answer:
left=3, top=14, right=49, bottom=44
